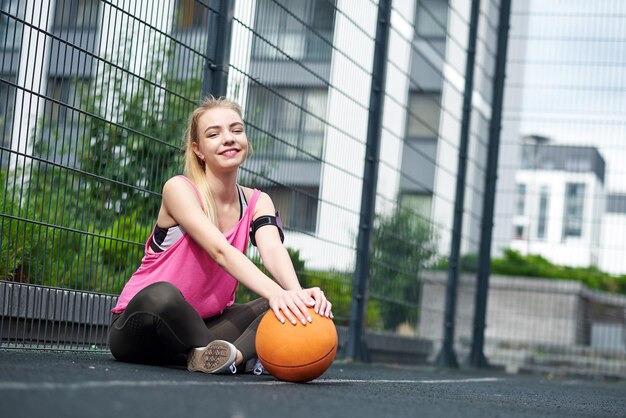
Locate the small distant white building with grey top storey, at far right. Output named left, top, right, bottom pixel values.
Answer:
left=510, top=143, right=605, bottom=267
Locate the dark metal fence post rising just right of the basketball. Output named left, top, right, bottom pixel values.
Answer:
left=346, top=0, right=391, bottom=361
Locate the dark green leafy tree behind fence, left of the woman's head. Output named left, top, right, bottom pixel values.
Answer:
left=81, top=48, right=196, bottom=226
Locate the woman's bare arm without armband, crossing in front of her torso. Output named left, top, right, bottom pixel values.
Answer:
left=163, top=177, right=313, bottom=324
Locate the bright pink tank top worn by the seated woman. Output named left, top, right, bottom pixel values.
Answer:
left=111, top=176, right=261, bottom=318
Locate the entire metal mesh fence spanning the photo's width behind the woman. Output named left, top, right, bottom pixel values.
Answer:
left=0, top=0, right=626, bottom=375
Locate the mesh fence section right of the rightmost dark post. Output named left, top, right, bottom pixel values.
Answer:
left=486, top=0, right=626, bottom=377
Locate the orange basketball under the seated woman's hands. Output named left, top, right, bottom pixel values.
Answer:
left=256, top=308, right=337, bottom=382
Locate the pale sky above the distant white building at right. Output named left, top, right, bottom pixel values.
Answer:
left=509, top=0, right=626, bottom=193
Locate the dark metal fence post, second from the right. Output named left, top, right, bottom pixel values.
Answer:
left=435, top=0, right=480, bottom=367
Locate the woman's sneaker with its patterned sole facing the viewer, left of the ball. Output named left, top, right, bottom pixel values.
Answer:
left=187, top=340, right=237, bottom=374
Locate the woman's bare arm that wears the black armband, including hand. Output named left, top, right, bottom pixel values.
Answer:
left=254, top=193, right=332, bottom=317
